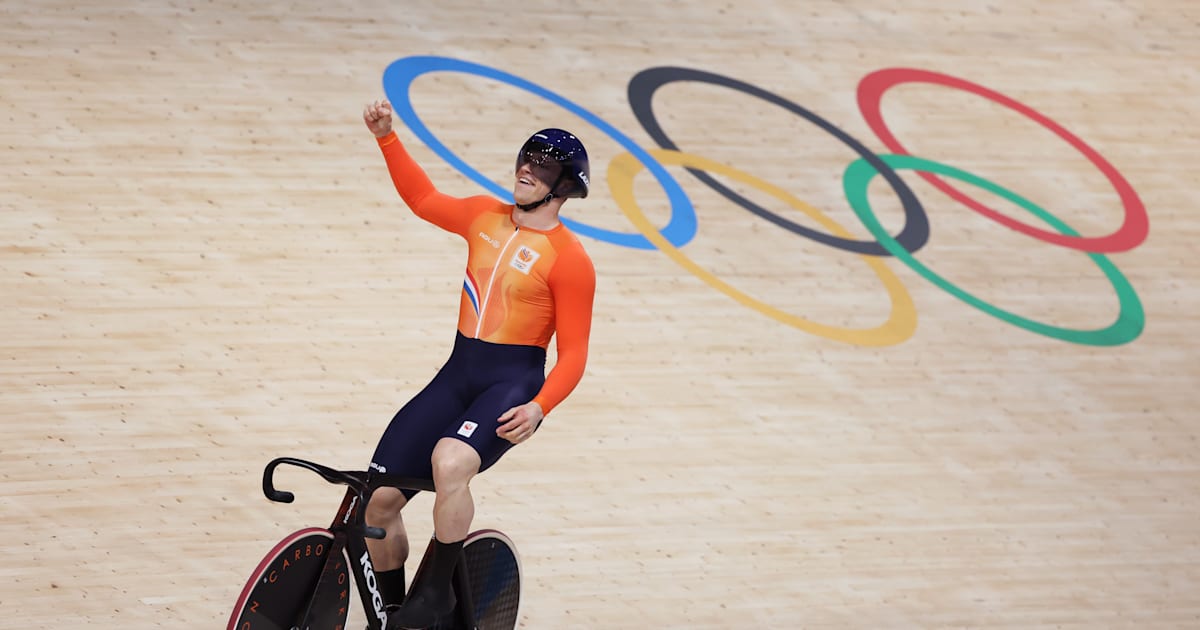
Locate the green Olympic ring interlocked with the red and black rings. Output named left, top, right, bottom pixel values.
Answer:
left=842, top=155, right=1146, bottom=346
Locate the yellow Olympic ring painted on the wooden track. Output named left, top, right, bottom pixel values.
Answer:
left=608, top=149, right=917, bottom=346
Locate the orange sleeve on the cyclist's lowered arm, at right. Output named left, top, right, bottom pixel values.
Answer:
left=533, top=241, right=596, bottom=415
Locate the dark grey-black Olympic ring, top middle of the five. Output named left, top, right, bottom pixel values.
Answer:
left=629, top=67, right=929, bottom=256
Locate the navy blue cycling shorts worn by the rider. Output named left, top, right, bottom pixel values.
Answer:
left=371, top=332, right=546, bottom=498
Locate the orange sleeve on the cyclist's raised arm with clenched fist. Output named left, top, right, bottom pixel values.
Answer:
left=378, top=132, right=478, bottom=236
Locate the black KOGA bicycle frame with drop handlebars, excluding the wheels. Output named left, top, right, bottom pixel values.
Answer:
left=263, top=457, right=475, bottom=630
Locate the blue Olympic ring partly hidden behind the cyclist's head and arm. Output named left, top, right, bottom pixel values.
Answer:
left=383, top=56, right=696, bottom=250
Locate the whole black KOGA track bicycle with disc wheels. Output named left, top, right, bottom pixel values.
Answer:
left=227, top=457, right=522, bottom=630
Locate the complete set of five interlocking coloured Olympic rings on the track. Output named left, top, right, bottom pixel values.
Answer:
left=384, top=56, right=1148, bottom=346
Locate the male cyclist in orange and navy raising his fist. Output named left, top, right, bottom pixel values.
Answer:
left=362, top=101, right=595, bottom=629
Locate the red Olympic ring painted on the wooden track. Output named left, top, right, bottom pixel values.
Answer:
left=858, top=68, right=1150, bottom=253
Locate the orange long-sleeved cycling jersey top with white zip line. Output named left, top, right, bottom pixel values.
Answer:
left=379, top=133, right=596, bottom=415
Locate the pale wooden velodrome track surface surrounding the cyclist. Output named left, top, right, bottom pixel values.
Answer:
left=0, top=0, right=1200, bottom=629
